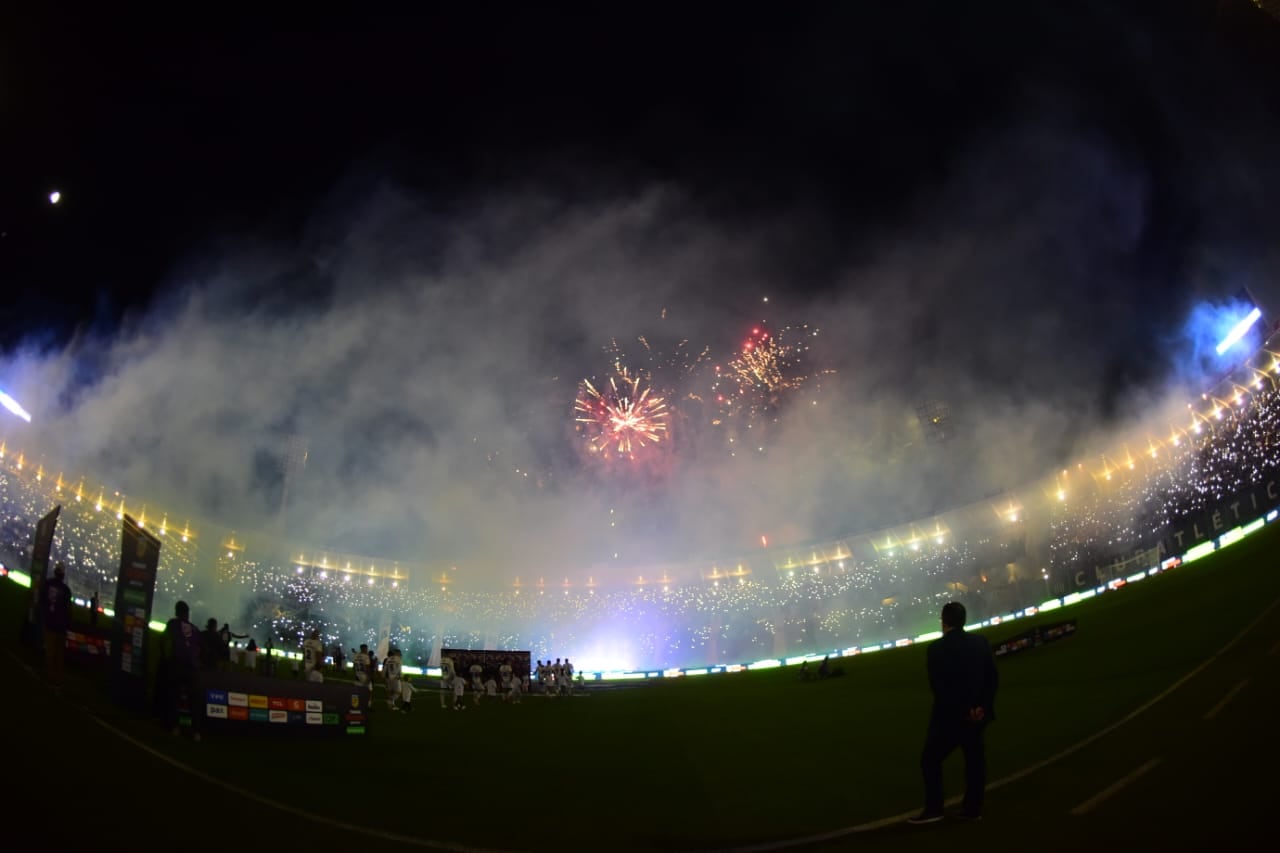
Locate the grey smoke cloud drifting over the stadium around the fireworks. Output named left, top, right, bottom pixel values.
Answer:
left=0, top=0, right=1280, bottom=607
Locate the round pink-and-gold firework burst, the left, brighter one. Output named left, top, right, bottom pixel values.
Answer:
left=573, top=362, right=671, bottom=460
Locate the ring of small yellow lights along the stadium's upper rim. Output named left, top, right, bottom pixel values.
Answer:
left=0, top=350, right=1280, bottom=596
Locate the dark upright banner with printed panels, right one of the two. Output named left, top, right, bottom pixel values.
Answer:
left=110, top=516, right=160, bottom=712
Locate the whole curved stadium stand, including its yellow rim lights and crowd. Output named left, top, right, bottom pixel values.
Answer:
left=0, top=326, right=1280, bottom=669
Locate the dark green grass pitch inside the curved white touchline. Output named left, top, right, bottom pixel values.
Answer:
left=5, top=528, right=1280, bottom=849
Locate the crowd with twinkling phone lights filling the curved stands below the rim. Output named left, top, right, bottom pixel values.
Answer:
left=0, top=371, right=1280, bottom=669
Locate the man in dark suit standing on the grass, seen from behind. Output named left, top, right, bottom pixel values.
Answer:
left=908, top=602, right=1000, bottom=824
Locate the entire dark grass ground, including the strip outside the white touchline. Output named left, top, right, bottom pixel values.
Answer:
left=0, top=525, right=1280, bottom=850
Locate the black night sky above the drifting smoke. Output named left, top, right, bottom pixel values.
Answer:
left=0, top=1, right=1280, bottom=342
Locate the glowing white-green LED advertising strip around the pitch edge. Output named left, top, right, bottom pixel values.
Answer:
left=0, top=510, right=1280, bottom=681
